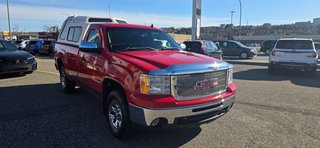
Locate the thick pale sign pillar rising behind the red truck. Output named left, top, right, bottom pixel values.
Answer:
left=192, top=0, right=201, bottom=40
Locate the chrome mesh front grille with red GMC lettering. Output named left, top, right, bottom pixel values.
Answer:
left=172, top=70, right=227, bottom=101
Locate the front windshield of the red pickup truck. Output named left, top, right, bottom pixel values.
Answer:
left=107, top=28, right=181, bottom=52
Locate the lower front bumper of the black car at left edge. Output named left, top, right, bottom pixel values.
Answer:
left=0, top=62, right=37, bottom=74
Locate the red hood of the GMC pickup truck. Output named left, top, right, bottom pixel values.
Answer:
left=116, top=51, right=220, bottom=70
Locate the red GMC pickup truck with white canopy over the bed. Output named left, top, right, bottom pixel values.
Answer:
left=54, top=17, right=236, bottom=138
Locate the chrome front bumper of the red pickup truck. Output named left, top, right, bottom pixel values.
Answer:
left=129, top=96, right=235, bottom=126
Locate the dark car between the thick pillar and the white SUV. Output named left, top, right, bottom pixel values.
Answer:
left=219, top=41, right=257, bottom=59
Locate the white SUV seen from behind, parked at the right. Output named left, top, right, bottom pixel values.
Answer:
left=268, top=38, right=318, bottom=76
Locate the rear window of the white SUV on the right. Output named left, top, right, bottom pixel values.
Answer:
left=276, top=40, right=313, bottom=49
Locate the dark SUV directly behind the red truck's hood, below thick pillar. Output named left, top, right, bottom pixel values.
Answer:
left=183, top=40, right=222, bottom=60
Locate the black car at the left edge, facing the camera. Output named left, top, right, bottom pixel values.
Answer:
left=0, top=40, right=37, bottom=74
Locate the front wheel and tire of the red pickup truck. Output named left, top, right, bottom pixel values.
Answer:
left=104, top=90, right=131, bottom=139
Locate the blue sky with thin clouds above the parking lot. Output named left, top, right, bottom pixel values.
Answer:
left=0, top=0, right=320, bottom=31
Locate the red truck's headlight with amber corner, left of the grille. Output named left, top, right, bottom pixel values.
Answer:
left=140, top=74, right=171, bottom=94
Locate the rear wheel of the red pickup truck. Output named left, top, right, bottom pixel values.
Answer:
left=59, top=66, right=76, bottom=94
